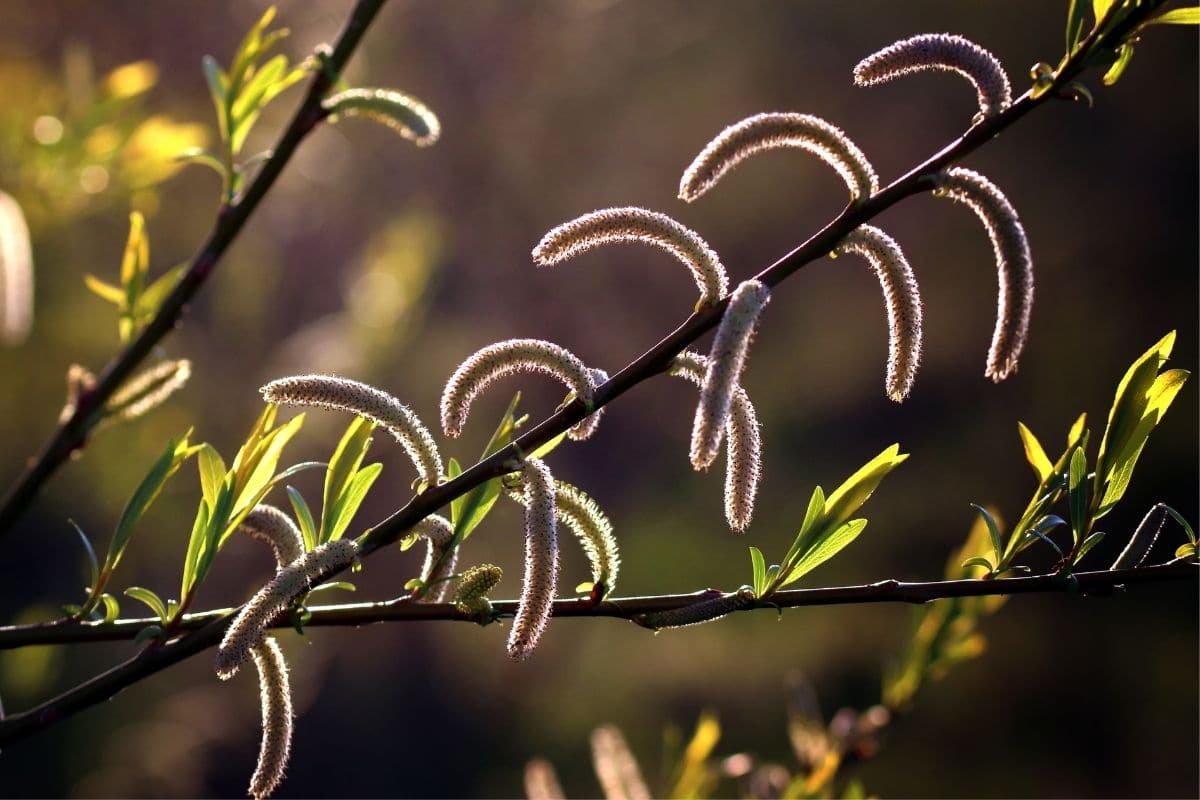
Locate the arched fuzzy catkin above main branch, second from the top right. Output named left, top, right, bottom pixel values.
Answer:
left=679, top=112, right=880, bottom=203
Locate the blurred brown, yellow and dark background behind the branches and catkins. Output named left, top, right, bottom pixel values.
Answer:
left=0, top=0, right=1200, bottom=798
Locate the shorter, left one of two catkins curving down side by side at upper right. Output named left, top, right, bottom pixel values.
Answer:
left=838, top=225, right=924, bottom=403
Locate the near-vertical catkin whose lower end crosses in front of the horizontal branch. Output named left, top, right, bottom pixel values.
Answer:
left=508, top=457, right=558, bottom=661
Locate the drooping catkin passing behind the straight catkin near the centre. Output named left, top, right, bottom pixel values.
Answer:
left=671, top=350, right=762, bottom=533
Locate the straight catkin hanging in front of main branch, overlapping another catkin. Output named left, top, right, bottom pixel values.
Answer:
left=691, top=281, right=770, bottom=469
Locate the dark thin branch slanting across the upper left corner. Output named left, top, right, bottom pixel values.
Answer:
left=0, top=0, right=384, bottom=537
